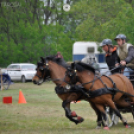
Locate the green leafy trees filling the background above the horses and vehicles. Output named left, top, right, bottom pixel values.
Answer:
left=0, top=0, right=134, bottom=67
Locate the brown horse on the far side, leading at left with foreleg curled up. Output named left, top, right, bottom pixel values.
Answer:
left=33, top=56, right=103, bottom=128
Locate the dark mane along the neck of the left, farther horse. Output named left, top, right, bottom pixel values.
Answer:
left=45, top=55, right=68, bottom=69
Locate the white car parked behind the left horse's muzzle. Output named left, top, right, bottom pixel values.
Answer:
left=5, top=63, right=36, bottom=83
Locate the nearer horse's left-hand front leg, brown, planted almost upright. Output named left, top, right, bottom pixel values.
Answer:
left=96, top=104, right=109, bottom=130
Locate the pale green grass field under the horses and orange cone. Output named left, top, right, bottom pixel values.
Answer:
left=0, top=83, right=134, bottom=134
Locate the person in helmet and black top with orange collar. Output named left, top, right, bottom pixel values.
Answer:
left=100, top=39, right=120, bottom=74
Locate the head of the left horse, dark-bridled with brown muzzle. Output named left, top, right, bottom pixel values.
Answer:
left=32, top=57, right=50, bottom=85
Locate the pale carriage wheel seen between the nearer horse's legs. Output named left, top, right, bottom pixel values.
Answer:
left=106, top=107, right=119, bottom=127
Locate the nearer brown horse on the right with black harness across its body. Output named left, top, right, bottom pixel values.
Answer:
left=68, top=62, right=134, bottom=128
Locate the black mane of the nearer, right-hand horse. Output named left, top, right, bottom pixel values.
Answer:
left=75, top=61, right=95, bottom=74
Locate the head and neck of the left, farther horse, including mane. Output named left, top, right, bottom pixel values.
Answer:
left=33, top=56, right=74, bottom=86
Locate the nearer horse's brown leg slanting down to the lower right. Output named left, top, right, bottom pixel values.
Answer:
left=107, top=100, right=129, bottom=128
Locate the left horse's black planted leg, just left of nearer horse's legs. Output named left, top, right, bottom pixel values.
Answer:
left=90, top=102, right=104, bottom=129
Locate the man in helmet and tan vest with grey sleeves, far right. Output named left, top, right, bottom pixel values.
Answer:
left=114, top=34, right=134, bottom=78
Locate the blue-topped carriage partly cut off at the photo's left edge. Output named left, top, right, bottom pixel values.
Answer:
left=0, top=73, right=13, bottom=90
